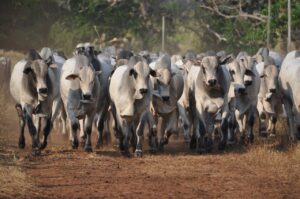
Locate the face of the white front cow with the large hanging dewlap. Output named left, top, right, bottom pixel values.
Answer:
left=129, top=61, right=156, bottom=99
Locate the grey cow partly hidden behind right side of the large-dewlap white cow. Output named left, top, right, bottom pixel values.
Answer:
left=151, top=54, right=184, bottom=150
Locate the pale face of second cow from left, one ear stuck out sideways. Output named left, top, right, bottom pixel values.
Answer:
left=66, top=66, right=101, bottom=103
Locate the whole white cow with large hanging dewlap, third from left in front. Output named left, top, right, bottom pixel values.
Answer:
left=109, top=56, right=156, bottom=157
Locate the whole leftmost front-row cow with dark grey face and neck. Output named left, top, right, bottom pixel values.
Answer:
left=10, top=50, right=59, bottom=154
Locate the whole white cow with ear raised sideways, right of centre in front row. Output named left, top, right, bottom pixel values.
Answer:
left=186, top=55, right=232, bottom=153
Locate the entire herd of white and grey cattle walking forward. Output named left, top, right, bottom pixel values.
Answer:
left=10, top=43, right=300, bottom=157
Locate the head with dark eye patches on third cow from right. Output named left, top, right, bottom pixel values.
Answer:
left=227, top=53, right=255, bottom=95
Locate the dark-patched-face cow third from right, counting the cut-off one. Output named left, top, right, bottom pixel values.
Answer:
left=227, top=52, right=260, bottom=143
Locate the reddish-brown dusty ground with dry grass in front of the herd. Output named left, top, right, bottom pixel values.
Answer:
left=0, top=97, right=300, bottom=198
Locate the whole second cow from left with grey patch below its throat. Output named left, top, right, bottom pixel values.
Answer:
left=60, top=55, right=101, bottom=152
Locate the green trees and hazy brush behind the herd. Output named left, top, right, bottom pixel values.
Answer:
left=0, top=0, right=300, bottom=54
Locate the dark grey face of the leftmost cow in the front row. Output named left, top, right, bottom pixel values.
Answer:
left=23, top=59, right=48, bottom=101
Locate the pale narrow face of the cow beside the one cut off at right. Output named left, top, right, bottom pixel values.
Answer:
left=260, top=64, right=279, bottom=100
